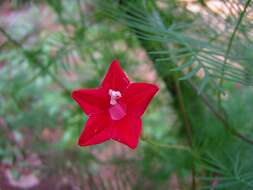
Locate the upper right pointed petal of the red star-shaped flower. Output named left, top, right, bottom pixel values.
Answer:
left=125, top=83, right=159, bottom=116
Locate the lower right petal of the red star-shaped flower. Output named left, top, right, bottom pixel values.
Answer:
left=112, top=116, right=141, bottom=149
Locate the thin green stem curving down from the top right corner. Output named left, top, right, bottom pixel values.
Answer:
left=218, top=0, right=251, bottom=106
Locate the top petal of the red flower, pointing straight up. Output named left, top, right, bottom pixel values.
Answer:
left=102, top=60, right=129, bottom=93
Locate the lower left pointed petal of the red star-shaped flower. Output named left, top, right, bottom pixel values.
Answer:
left=78, top=114, right=112, bottom=146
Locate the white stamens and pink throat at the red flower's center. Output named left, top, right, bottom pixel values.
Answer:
left=109, top=89, right=126, bottom=120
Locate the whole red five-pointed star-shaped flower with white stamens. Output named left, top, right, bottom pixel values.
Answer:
left=72, top=60, right=159, bottom=149
